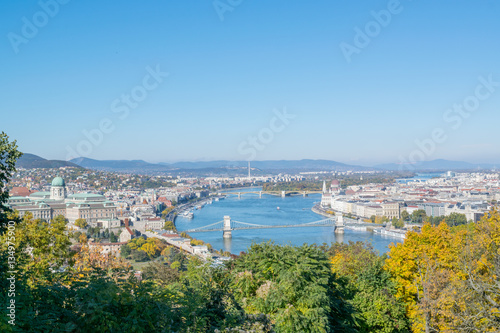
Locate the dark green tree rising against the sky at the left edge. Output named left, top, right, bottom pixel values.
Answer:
left=0, top=132, right=22, bottom=230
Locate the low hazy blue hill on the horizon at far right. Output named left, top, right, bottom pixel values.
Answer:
left=375, top=159, right=495, bottom=171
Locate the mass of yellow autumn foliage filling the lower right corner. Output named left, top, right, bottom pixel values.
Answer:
left=385, top=211, right=500, bottom=332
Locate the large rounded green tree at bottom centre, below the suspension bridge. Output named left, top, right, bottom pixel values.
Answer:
left=231, top=242, right=352, bottom=332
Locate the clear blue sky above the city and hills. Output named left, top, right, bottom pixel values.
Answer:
left=0, top=0, right=500, bottom=165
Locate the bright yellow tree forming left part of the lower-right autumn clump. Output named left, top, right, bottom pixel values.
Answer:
left=385, top=219, right=465, bottom=332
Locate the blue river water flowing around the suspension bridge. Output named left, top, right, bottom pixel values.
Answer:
left=176, top=188, right=402, bottom=254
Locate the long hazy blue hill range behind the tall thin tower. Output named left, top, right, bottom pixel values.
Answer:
left=71, top=157, right=373, bottom=173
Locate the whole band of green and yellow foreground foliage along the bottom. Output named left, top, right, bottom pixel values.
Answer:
left=0, top=211, right=500, bottom=332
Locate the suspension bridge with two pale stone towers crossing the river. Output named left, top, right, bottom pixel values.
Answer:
left=184, top=216, right=344, bottom=238
